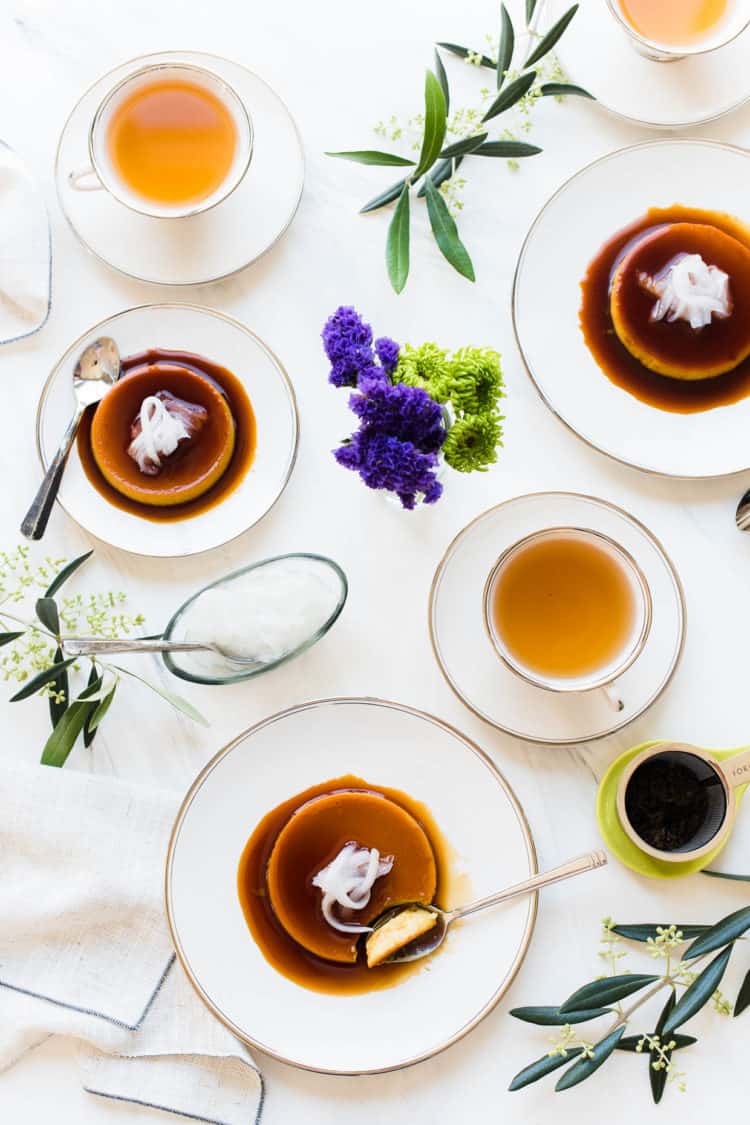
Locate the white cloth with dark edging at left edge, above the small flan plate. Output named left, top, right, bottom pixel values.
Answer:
left=0, top=141, right=52, bottom=344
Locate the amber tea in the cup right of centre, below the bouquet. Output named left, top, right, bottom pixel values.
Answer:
left=491, top=532, right=635, bottom=678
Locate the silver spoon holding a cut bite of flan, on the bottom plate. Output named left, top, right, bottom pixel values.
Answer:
left=365, top=852, right=607, bottom=964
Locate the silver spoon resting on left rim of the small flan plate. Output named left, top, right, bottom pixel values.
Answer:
left=21, top=336, right=120, bottom=539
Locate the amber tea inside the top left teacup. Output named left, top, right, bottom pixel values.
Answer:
left=107, top=79, right=237, bottom=205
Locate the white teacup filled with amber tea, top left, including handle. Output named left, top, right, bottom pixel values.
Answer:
left=71, top=63, right=253, bottom=218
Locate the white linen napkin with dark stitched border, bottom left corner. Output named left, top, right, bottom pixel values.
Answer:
left=0, top=766, right=263, bottom=1125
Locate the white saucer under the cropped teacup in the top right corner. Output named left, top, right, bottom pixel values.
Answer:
left=545, top=0, right=750, bottom=129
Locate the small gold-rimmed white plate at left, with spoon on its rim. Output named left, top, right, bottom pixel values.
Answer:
left=36, top=305, right=299, bottom=558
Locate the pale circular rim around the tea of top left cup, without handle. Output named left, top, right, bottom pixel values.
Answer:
left=88, top=61, right=255, bottom=219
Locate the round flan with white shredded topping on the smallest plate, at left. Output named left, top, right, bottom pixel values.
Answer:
left=91, top=362, right=235, bottom=507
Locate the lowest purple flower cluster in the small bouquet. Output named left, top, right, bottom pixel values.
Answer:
left=334, top=428, right=443, bottom=509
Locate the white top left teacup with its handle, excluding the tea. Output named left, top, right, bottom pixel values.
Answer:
left=69, top=63, right=253, bottom=218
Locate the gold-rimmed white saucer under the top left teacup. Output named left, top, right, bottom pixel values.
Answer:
left=55, top=51, right=305, bottom=285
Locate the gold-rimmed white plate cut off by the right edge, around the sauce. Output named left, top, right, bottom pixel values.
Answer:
left=513, top=140, right=750, bottom=478
